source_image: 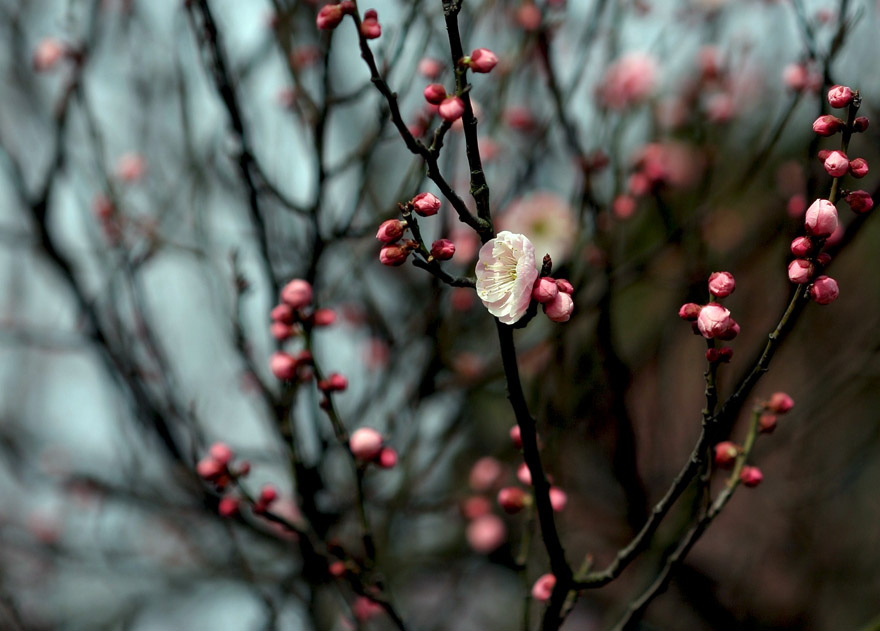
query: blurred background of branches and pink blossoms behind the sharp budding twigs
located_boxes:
[0,0,880,631]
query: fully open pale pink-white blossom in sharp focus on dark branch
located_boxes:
[476,230,538,324]
